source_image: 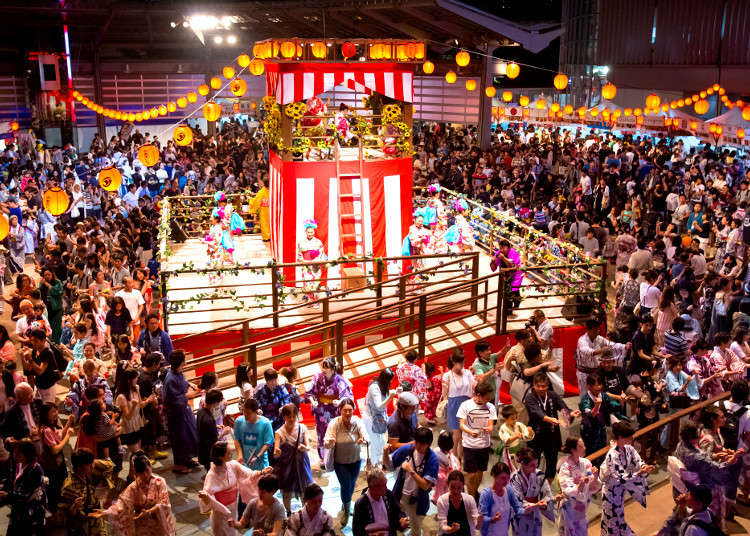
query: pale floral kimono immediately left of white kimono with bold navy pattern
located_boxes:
[558,457,602,536]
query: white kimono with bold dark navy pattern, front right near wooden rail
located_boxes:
[599,445,649,536]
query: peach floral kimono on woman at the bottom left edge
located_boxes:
[105,475,176,536]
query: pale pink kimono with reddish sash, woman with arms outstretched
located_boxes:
[198,460,260,536]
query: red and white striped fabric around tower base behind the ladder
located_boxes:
[269,152,412,280]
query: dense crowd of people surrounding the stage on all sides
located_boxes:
[0,115,750,536]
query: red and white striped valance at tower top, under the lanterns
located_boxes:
[266,63,414,104]
